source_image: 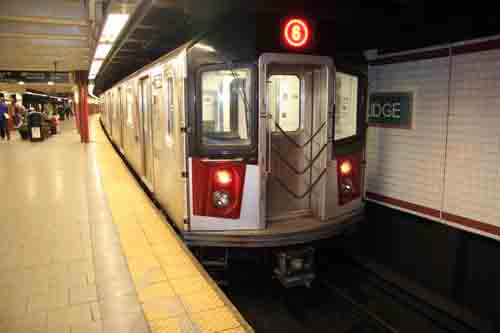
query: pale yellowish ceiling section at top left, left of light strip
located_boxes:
[0,0,90,71]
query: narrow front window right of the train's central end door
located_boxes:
[335,72,358,141]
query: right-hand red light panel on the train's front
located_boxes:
[337,153,361,205]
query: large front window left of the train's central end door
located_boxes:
[201,69,251,146]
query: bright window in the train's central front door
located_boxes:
[268,75,301,132]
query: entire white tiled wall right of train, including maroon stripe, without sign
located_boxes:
[366,37,500,239]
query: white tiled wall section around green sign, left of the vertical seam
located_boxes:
[366,58,449,209]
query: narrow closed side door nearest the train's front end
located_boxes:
[139,77,153,190]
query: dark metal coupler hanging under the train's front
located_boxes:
[274,246,316,288]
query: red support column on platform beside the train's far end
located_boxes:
[74,71,89,143]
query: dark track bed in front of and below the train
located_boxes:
[225,245,492,333]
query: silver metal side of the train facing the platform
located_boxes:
[102,50,187,228]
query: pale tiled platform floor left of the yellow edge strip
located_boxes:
[0,120,148,333]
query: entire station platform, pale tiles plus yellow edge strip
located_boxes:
[0,116,253,333]
